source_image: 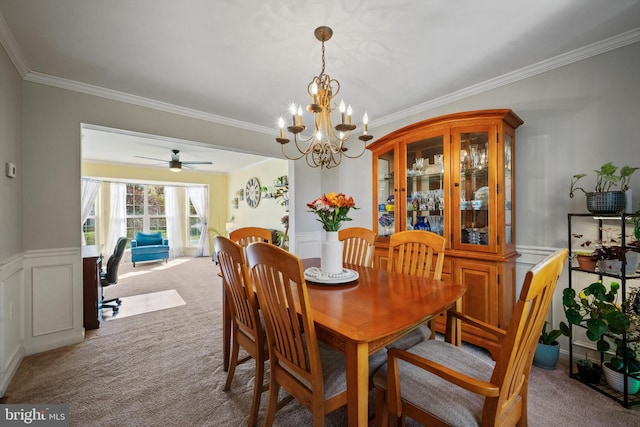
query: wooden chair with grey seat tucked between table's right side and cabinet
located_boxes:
[387,230,445,349]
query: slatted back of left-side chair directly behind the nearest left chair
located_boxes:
[213,236,262,342]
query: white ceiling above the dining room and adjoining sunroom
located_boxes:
[0,0,640,172]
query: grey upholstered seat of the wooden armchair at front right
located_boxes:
[373,340,494,427]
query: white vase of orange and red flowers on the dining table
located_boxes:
[307,193,357,276]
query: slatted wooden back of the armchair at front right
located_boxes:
[483,249,568,425]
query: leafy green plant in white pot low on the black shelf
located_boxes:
[560,281,640,394]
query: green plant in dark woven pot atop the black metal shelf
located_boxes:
[569,162,638,214]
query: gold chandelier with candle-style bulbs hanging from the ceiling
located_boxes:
[276,27,373,169]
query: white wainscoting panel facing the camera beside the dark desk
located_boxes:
[24,248,84,354]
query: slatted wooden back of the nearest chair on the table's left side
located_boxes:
[247,242,324,403]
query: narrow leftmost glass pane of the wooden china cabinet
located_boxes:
[378,150,396,236]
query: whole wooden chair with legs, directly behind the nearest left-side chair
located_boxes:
[213,236,269,426]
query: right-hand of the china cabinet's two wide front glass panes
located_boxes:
[458,132,493,246]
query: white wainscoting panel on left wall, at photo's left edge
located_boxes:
[0,254,24,396]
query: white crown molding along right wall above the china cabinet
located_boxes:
[376,27,640,128]
